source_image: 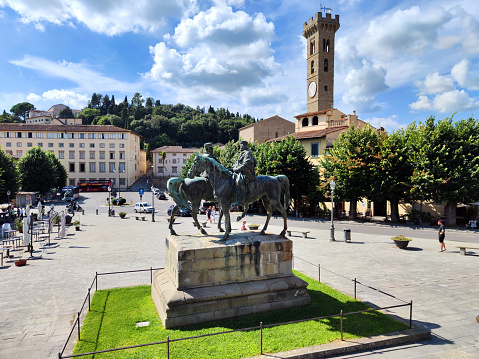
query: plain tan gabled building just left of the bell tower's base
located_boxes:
[238,115,295,143]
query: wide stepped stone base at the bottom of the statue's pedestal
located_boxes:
[151,269,311,329]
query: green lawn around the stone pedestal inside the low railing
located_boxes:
[74,272,407,359]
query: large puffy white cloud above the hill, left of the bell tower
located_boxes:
[144,6,279,103]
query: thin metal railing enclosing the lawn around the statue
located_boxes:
[58,266,412,359]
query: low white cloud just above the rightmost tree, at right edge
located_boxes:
[409,90,479,113]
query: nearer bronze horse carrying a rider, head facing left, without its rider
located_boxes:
[188,155,290,241]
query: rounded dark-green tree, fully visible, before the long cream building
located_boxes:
[17,146,57,195]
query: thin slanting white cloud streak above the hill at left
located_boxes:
[10,55,134,92]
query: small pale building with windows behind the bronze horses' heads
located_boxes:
[151,146,201,178]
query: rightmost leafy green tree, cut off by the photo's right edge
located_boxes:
[412,117,479,225]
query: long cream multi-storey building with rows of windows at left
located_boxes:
[0,123,146,189]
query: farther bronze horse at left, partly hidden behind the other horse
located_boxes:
[166,177,224,235]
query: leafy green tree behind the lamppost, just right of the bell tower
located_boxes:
[321,126,380,219]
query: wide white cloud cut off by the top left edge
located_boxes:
[0,0,197,36]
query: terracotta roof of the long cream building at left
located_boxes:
[0,123,139,136]
